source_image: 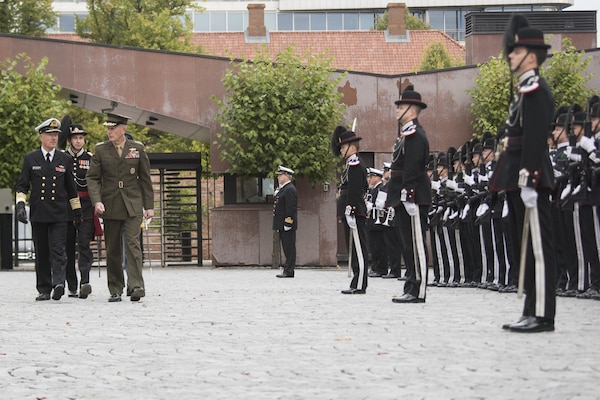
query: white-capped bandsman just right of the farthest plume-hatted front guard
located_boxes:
[367,168,388,278]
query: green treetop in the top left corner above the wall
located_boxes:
[0,0,58,36]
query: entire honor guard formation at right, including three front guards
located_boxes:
[332,15,600,332]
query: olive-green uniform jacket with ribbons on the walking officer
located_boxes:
[87,140,154,220]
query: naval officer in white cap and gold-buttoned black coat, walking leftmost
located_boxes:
[16,118,81,301]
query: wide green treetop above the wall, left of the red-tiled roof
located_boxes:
[75,0,202,52]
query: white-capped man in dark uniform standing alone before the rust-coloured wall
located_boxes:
[273,165,298,278]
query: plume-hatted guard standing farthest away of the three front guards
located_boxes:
[331,126,368,294]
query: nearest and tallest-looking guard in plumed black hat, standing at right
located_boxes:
[490,15,556,332]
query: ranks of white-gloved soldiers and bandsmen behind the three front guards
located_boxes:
[365,97,600,300]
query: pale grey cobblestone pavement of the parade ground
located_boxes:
[0,267,600,400]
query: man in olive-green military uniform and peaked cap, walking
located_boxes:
[87,114,154,303]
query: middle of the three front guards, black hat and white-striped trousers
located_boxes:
[386,86,431,303]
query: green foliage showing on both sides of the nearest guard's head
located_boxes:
[467,38,595,139]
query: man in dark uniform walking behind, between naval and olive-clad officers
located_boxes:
[66,125,94,299]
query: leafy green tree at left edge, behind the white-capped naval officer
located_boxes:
[0,53,68,188]
